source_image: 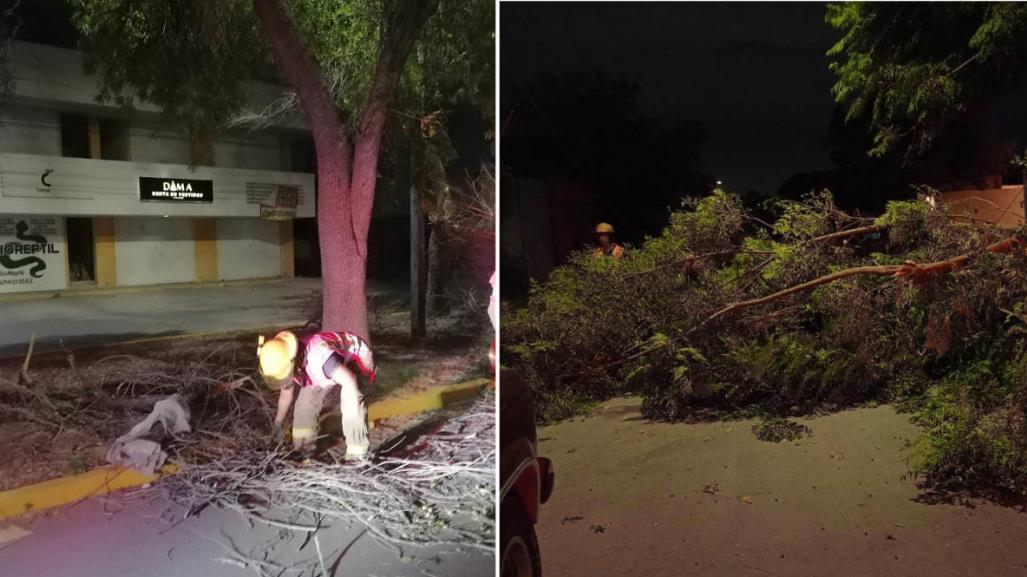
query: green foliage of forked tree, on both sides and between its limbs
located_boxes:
[71,0,494,150]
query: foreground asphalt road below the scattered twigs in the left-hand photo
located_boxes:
[0,491,495,577]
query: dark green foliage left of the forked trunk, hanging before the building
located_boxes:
[71,0,263,133]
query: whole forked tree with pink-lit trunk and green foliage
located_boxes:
[72,0,492,337]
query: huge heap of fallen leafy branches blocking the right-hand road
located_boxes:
[503,191,1027,493]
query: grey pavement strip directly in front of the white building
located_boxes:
[0,278,320,357]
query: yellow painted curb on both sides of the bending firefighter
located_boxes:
[0,378,491,522]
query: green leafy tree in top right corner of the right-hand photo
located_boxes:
[827,2,1027,182]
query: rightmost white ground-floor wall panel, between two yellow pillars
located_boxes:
[218,219,281,280]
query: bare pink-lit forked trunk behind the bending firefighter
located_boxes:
[254,0,435,342]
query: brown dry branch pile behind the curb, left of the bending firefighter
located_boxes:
[0,343,273,461]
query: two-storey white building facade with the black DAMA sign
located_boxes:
[0,43,316,294]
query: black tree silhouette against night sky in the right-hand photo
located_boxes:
[501,70,710,242]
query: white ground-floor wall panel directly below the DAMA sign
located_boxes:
[114,217,196,286]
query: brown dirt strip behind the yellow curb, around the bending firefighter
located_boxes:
[0,312,488,491]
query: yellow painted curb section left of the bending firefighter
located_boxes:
[0,465,178,521]
